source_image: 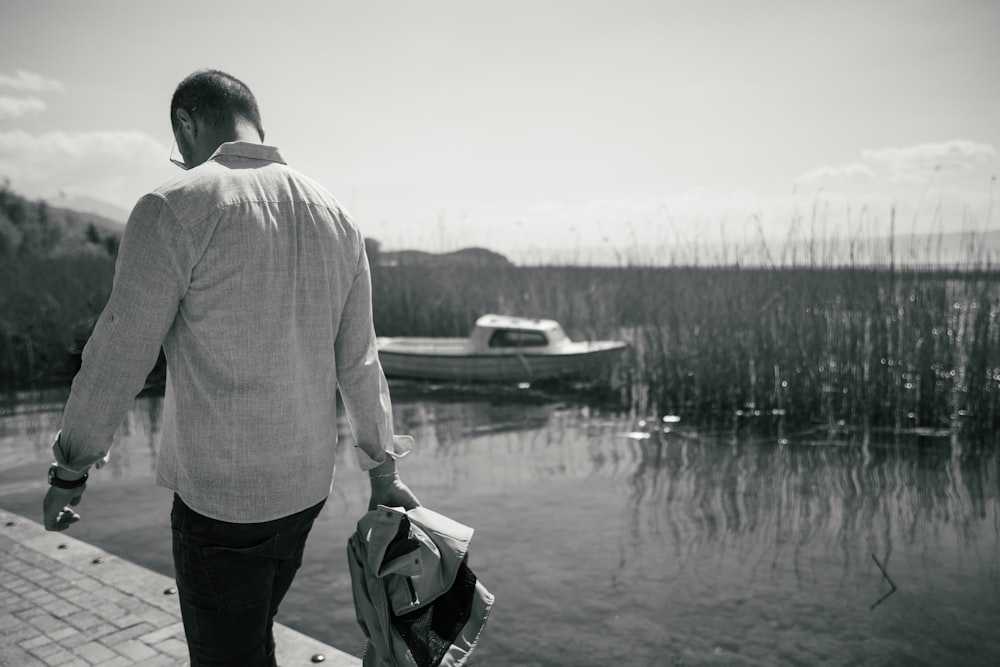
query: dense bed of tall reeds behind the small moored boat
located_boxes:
[373,266,1000,437]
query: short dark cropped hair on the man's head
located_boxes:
[170,69,264,141]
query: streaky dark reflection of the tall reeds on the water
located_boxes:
[604,431,1000,585]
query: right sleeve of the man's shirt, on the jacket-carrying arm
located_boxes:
[335,235,413,470]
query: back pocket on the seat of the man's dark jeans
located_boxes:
[198,535,278,611]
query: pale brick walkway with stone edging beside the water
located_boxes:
[0,508,361,667]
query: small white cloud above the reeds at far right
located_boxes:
[861,140,997,180]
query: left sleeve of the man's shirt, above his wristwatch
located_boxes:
[53,194,192,472]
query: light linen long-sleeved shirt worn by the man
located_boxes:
[53,142,406,523]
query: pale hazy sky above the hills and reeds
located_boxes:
[0,0,1000,263]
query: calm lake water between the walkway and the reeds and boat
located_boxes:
[0,385,1000,666]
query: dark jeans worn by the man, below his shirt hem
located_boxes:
[170,494,326,667]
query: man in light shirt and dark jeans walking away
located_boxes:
[43,70,419,667]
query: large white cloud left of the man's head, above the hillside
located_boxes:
[0,130,175,208]
